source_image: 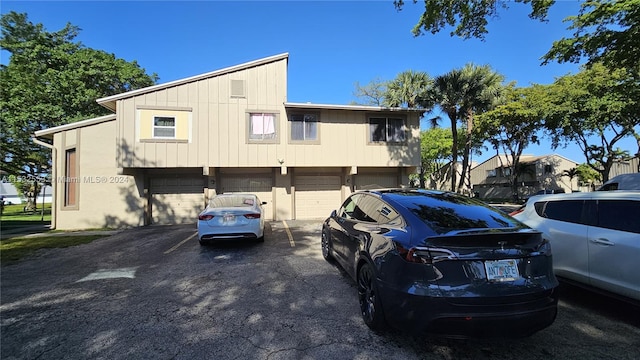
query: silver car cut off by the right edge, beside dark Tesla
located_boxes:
[512,190,640,300]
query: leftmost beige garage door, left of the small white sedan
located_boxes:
[150,176,204,224]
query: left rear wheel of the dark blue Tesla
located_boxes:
[357,264,386,331]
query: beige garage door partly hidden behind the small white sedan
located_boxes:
[220,174,273,220]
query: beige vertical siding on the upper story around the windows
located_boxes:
[116,59,420,172]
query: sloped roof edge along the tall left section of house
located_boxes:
[96,53,289,111]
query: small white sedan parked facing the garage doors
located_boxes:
[197,193,266,245]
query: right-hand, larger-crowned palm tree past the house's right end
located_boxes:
[426,64,504,191]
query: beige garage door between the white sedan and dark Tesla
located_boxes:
[295,176,342,219]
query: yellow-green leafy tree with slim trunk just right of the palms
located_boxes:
[476,84,545,200]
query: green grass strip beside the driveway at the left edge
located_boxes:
[0,235,109,266]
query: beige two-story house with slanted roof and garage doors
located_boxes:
[35,53,423,229]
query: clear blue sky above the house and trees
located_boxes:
[0,0,637,163]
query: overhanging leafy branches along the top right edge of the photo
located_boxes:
[394,0,640,71]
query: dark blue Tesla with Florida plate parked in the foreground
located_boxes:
[321,189,558,337]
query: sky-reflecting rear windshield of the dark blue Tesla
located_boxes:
[394,192,524,235]
